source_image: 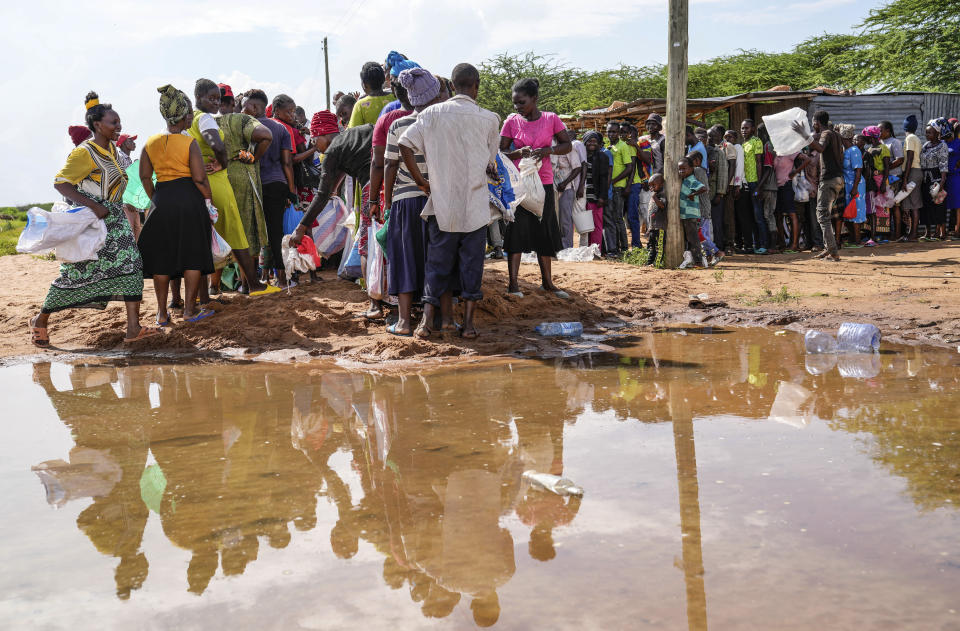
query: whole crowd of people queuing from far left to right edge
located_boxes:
[29,51,960,346]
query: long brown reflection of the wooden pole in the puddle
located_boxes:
[670,383,707,631]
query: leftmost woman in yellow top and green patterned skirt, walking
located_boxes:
[29,92,158,347]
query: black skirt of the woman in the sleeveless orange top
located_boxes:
[137,177,213,278]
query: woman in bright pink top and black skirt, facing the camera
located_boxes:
[500,79,573,298]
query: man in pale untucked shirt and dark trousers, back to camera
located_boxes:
[400,64,500,339]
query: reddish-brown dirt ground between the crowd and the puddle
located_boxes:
[0,242,960,363]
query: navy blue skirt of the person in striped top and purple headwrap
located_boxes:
[387,197,427,301]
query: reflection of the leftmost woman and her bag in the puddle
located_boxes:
[33,363,150,600]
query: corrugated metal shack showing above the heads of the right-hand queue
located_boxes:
[571,90,960,133]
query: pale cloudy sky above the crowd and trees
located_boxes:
[0,0,876,205]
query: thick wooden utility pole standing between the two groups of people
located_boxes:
[663,0,689,268]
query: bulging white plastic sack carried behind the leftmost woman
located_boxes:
[17,202,107,263]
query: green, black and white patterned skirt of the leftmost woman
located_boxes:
[43,196,143,313]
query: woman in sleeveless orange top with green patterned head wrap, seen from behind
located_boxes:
[138,85,213,326]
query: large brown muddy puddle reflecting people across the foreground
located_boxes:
[0,328,960,630]
